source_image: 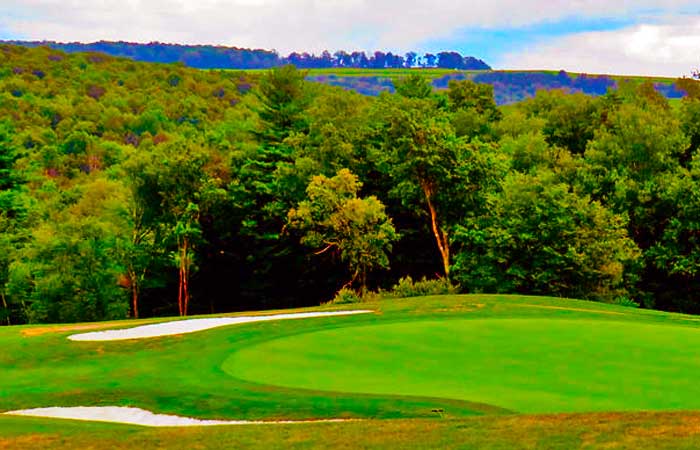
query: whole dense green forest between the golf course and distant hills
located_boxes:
[0,45,700,324]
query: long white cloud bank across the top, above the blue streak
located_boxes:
[0,0,697,52]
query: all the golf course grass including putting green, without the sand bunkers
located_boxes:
[0,295,700,449]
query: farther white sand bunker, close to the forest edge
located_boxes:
[68,310,373,341]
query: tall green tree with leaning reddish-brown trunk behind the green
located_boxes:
[374,96,500,276]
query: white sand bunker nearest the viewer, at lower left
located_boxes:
[3,406,357,427]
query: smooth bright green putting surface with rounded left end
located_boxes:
[224,319,700,413]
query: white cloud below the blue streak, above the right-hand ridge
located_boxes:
[497,16,700,77]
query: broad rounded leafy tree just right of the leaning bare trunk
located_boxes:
[454,172,639,301]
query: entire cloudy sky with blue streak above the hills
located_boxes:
[0,0,700,77]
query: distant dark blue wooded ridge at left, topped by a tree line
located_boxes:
[0,41,491,70]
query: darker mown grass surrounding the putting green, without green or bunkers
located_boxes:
[0,296,700,448]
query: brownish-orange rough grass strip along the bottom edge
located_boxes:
[0,412,700,450]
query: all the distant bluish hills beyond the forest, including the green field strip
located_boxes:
[0,41,684,105]
